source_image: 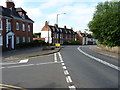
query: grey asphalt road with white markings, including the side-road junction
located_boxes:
[1,46,119,90]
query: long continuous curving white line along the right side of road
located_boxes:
[77,47,120,71]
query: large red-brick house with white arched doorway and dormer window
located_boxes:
[0,0,34,50]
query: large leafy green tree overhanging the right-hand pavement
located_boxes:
[88,1,120,47]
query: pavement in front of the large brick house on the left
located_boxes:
[2,47,61,61]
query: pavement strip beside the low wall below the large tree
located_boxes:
[89,45,120,59]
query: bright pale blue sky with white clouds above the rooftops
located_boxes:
[0,0,114,33]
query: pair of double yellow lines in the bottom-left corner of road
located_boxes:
[0,84,27,90]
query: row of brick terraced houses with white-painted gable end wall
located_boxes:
[41,21,75,44]
